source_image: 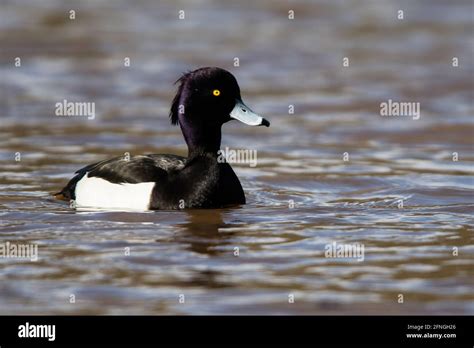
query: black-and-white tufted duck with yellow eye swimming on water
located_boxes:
[55,67,270,210]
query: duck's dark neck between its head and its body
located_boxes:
[181,120,222,158]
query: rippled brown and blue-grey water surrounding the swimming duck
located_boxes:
[0,0,474,314]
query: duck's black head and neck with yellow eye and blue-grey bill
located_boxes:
[170,67,270,155]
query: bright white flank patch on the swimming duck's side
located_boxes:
[76,173,155,210]
